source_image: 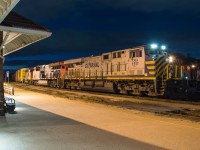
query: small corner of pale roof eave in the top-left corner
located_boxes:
[0,0,20,23]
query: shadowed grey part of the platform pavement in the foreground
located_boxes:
[0,102,162,150]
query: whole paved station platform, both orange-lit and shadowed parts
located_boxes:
[0,88,200,150]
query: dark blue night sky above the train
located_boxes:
[4,0,200,70]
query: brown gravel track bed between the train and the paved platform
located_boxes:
[10,83,200,122]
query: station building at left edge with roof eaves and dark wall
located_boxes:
[0,0,51,116]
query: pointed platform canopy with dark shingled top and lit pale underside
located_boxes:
[0,11,51,56]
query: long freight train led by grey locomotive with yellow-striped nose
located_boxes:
[15,45,200,98]
